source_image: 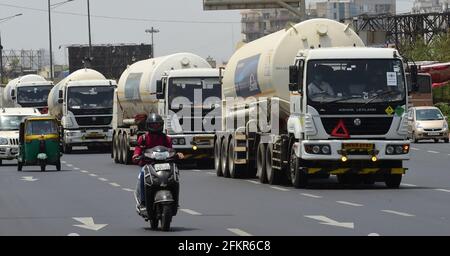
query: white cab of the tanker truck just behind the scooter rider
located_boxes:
[157,68,222,160]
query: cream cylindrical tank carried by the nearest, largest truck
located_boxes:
[222,19,364,116]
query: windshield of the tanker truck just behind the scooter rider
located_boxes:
[168,78,222,109]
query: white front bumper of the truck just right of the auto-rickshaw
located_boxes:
[64,129,113,146]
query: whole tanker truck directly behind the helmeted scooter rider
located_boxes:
[111,53,222,165]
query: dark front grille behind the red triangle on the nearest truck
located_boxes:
[322,117,393,135]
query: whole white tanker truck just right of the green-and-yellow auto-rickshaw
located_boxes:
[48,69,116,153]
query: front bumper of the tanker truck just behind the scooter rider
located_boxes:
[170,134,214,160]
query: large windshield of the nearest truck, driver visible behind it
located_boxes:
[307,59,406,104]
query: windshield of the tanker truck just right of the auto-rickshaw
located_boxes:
[67,86,114,112]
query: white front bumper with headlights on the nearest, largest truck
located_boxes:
[294,140,410,161]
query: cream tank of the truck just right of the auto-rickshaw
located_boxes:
[48,68,106,118]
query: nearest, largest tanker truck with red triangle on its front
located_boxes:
[214,19,409,188]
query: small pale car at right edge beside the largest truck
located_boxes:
[408,107,449,143]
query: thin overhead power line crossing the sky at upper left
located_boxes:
[0,4,240,24]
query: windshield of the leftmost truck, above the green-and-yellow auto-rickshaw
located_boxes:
[17,85,52,106]
